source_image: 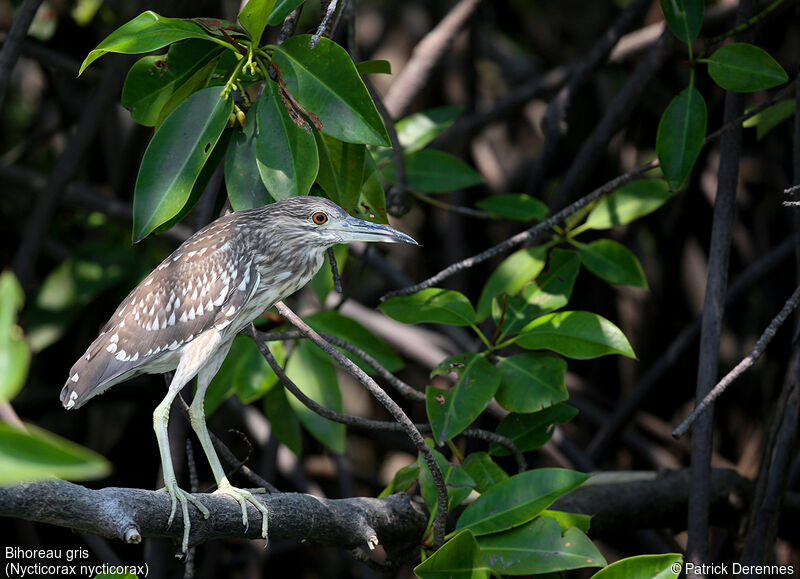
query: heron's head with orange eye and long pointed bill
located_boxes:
[265,196,419,247]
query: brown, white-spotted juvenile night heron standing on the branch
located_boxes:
[61,197,416,551]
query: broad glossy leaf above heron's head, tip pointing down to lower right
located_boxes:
[272,35,389,147]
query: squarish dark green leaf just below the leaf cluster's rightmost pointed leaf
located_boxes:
[495,352,569,412]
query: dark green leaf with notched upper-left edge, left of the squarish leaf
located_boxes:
[425,352,500,444]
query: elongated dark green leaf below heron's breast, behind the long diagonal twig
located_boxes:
[305,310,403,374]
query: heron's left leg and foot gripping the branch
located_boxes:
[153,365,210,553]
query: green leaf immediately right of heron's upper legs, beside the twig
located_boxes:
[205,336,283,416]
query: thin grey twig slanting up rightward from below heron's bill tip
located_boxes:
[381,160,658,301]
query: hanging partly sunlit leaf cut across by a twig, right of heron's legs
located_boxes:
[286,342,345,453]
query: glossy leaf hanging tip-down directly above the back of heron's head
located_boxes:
[256,82,319,201]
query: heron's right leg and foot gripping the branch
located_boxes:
[189,343,268,539]
